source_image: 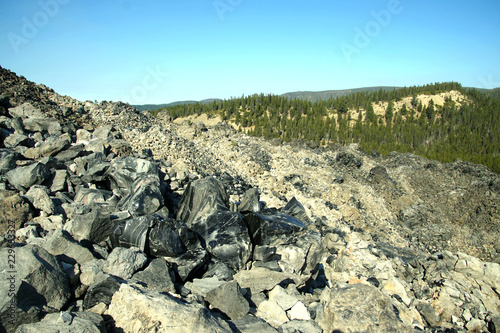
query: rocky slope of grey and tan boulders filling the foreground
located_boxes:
[0,68,500,332]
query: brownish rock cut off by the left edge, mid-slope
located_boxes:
[0,190,33,236]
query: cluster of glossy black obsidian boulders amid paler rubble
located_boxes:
[110,177,309,281]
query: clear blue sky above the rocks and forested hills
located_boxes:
[0,0,500,104]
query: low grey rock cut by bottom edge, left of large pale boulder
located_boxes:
[16,312,106,333]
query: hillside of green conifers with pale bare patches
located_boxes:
[151,82,500,173]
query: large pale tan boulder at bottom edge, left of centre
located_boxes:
[107,284,232,333]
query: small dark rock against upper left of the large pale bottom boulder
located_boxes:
[83,274,125,310]
